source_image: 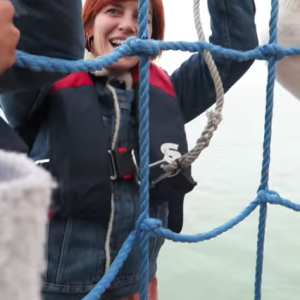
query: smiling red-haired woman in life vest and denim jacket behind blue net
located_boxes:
[0,0,258,300]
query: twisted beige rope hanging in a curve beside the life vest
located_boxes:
[162,0,224,173]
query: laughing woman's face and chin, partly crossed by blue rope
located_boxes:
[90,0,152,71]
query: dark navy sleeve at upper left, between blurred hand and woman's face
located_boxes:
[0,0,84,125]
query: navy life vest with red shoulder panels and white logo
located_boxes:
[25,64,195,224]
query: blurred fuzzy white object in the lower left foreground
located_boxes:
[0,150,55,300]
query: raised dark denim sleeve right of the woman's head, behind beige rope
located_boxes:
[171,0,258,123]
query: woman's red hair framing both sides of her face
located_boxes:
[82,0,165,57]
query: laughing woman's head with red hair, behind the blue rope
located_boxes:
[82,0,165,70]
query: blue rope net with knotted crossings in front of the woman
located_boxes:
[12,0,300,300]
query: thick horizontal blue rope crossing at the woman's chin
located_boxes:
[15,37,300,74]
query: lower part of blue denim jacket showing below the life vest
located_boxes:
[43,199,167,300]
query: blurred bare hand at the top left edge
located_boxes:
[0,0,20,75]
